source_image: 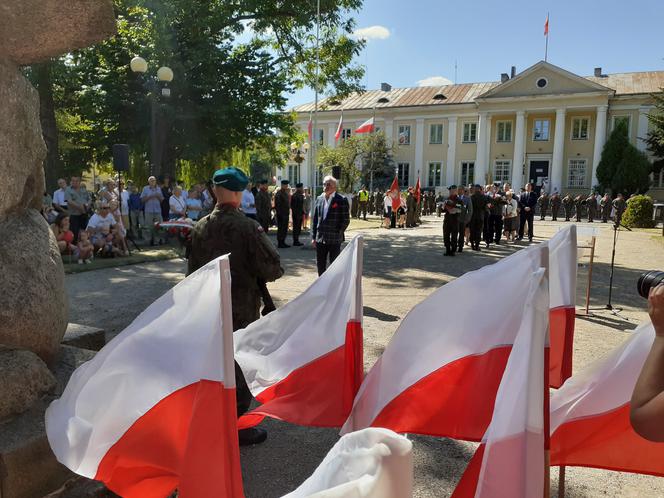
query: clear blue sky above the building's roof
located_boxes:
[288,0,664,108]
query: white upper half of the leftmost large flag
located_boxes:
[46,256,234,478]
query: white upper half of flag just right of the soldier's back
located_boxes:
[234,236,362,396]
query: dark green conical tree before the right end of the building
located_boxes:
[597,123,652,195]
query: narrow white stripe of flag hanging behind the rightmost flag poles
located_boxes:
[547,225,577,309]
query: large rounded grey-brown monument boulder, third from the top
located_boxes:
[0,209,67,364]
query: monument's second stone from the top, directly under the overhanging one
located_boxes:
[0,57,46,220]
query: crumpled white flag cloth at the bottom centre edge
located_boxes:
[283,428,413,498]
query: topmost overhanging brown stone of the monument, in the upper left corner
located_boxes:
[0,0,115,65]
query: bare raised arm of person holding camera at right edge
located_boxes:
[630,282,664,442]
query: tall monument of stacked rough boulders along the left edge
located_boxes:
[0,0,115,498]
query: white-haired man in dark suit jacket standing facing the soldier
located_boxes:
[311,176,350,276]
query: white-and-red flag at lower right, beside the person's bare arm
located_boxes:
[551,322,664,476]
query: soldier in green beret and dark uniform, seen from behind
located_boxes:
[189,168,284,445]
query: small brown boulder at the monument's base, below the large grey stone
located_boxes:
[0,347,56,420]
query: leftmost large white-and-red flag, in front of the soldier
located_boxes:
[46,256,244,498]
